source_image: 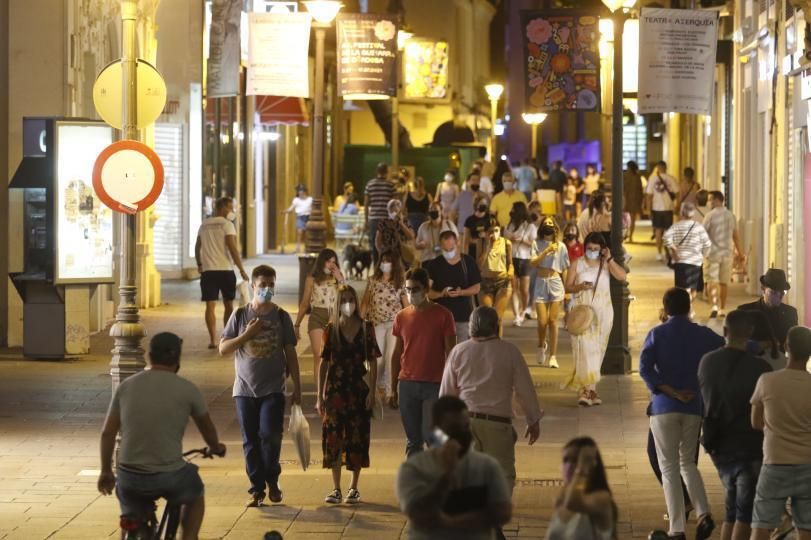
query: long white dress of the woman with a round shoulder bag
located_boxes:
[566,257,614,390]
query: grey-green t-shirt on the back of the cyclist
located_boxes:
[108,369,208,473]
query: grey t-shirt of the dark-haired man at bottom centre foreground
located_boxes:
[397,448,511,540]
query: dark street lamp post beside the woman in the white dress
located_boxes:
[602,0,636,375]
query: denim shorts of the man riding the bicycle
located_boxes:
[115,463,204,518]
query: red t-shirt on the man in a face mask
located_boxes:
[393,303,456,383]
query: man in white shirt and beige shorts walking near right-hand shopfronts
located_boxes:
[703,191,744,319]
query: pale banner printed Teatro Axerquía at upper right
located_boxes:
[628,8,718,115]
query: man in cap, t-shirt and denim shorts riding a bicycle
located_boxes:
[98,332,225,540]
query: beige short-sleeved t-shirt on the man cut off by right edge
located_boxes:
[752,369,811,465]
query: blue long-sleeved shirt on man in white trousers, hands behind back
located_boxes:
[639,317,725,416]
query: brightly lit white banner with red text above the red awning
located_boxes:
[246,13,311,97]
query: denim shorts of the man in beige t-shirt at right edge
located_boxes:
[752,465,811,530]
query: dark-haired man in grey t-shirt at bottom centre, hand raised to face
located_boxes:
[396,396,512,540]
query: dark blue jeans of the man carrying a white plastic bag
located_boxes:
[234,393,285,494]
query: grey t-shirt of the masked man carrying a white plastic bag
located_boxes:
[222,304,296,397]
